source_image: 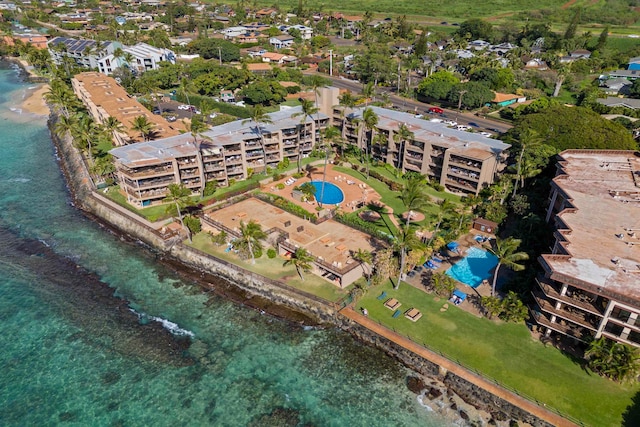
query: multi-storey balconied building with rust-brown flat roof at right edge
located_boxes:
[532,150,640,347]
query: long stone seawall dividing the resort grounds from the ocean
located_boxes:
[49,115,568,427]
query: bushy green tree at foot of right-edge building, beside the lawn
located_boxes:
[584,336,640,381]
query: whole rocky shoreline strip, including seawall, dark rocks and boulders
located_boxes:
[41,77,550,427]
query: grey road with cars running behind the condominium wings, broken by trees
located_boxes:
[321,74,512,133]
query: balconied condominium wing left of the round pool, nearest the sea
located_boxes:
[110,107,329,206]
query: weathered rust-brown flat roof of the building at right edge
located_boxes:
[543,150,640,300]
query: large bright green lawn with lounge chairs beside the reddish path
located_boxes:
[356,283,640,426]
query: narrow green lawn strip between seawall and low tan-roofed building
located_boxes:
[187,233,356,301]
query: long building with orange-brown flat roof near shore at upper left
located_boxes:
[71,71,184,145]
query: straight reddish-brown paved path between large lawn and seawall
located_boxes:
[340,307,577,427]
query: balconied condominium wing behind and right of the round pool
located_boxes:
[333,107,510,195]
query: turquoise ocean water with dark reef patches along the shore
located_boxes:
[0,63,448,426]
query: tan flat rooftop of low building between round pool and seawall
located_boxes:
[209,198,378,267]
